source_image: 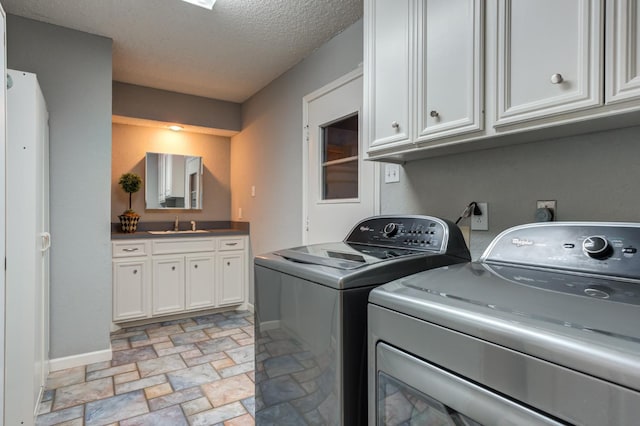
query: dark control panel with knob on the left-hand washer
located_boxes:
[345,216,460,251]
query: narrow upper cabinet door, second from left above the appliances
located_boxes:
[415,0,484,140]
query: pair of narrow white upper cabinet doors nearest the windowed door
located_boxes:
[364,0,484,153]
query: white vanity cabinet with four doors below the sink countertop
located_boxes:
[112,236,248,322]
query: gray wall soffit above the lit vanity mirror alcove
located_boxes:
[113,81,241,130]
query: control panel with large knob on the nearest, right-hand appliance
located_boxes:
[480,222,640,279]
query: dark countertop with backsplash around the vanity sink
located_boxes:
[111,221,249,240]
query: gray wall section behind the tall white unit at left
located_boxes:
[7,15,111,358]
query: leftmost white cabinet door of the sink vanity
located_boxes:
[113,259,149,321]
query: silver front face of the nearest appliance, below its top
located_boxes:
[368,303,640,426]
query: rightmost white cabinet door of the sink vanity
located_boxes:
[218,251,246,306]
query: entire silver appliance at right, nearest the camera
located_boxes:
[368,222,640,426]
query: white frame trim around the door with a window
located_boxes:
[301,65,380,245]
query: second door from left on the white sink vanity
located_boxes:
[152,256,184,315]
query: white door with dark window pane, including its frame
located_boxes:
[303,69,379,244]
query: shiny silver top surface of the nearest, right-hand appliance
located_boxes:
[369,263,640,390]
